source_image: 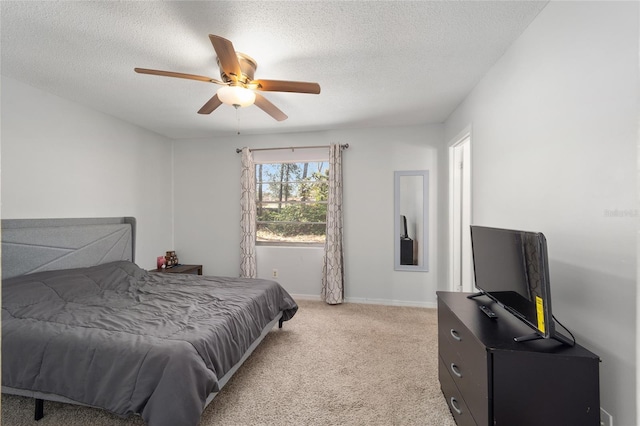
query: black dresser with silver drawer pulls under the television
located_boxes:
[438,292,600,426]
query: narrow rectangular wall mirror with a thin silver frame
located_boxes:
[393,170,429,271]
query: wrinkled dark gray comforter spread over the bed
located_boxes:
[2,261,297,426]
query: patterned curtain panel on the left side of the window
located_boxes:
[240,147,258,278]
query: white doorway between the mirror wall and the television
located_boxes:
[449,131,474,292]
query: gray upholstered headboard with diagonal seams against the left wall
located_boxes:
[2,217,136,279]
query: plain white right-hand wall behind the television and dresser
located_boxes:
[445,2,639,426]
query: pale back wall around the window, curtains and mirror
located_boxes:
[174,125,443,306]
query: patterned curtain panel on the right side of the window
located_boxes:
[321,144,344,305]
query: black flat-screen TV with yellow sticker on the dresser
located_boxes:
[470,225,575,345]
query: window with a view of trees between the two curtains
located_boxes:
[256,161,329,244]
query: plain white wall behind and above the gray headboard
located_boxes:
[0,77,172,268]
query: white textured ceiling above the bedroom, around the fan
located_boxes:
[0,0,547,139]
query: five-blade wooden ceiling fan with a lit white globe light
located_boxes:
[134,34,320,121]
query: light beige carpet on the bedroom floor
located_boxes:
[2,300,455,426]
